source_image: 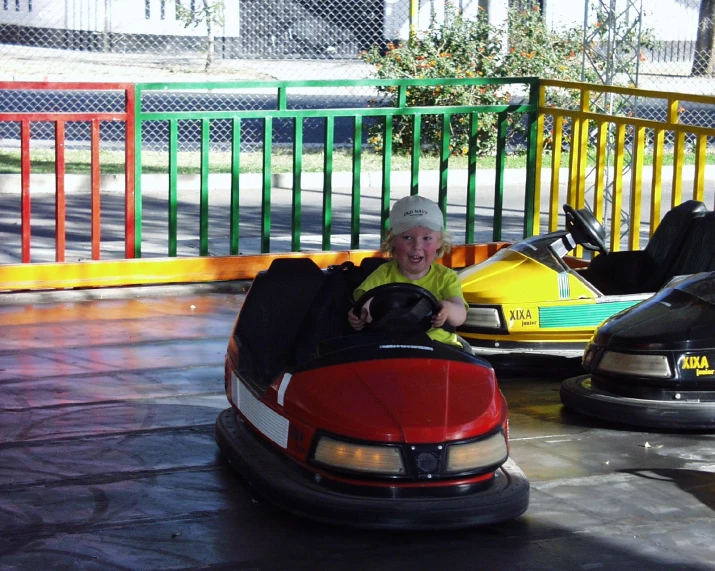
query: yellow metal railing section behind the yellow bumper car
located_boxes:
[534,80,715,251]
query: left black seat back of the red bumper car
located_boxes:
[234,258,325,387]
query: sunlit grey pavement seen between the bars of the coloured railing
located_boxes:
[0,165,715,264]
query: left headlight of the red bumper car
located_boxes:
[313,436,406,476]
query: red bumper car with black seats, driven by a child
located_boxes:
[216,259,529,529]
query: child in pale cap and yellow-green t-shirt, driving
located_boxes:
[348,195,468,347]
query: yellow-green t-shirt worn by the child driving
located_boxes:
[353,260,469,347]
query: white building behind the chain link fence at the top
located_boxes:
[0,0,698,57]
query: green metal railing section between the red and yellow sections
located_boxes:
[134,77,539,258]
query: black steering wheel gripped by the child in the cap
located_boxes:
[353,283,440,333]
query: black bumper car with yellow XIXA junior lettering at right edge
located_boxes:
[561,272,715,430]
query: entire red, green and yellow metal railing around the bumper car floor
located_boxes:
[0,78,715,290]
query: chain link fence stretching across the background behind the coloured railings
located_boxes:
[0,0,715,155]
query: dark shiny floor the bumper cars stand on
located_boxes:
[0,290,715,571]
